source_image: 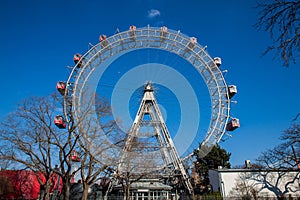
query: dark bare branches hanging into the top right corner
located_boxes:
[255,0,300,67]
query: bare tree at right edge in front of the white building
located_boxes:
[253,123,300,198]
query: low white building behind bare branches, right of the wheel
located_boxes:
[209,169,300,199]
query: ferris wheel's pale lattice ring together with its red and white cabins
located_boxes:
[56,26,239,191]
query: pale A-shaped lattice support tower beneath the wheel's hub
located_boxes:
[118,83,193,193]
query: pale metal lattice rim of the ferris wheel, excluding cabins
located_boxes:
[64,26,230,159]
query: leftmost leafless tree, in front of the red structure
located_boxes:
[0,96,77,199]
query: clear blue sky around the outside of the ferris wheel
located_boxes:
[0,0,300,165]
